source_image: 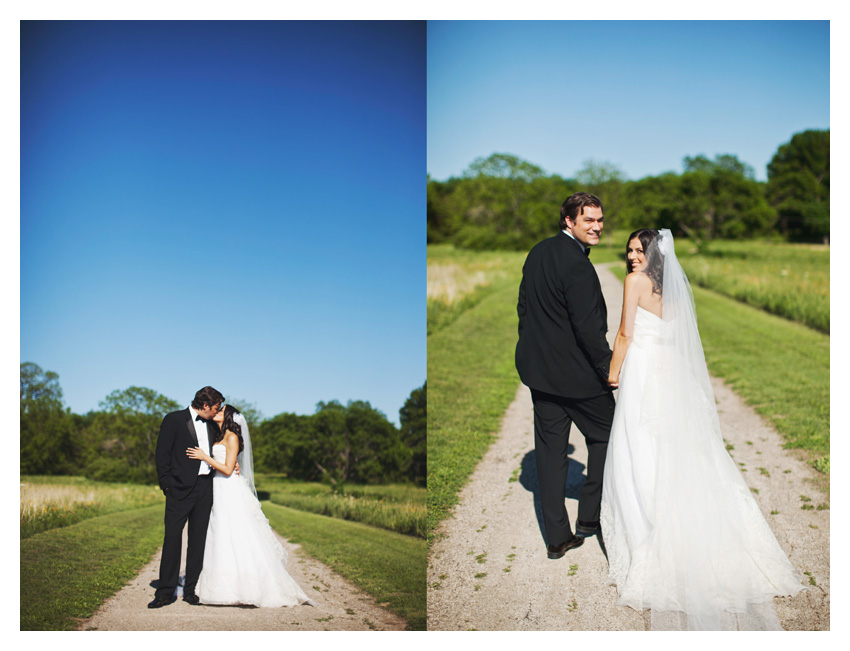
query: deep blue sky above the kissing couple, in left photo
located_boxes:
[20,21,426,423]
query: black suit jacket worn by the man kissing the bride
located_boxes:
[156,407,219,499]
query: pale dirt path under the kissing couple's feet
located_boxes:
[80,531,406,631]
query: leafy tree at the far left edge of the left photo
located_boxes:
[20,362,78,475]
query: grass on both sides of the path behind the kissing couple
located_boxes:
[20,477,426,630]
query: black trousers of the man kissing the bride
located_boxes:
[156,473,213,597]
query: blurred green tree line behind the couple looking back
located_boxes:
[428,130,829,250]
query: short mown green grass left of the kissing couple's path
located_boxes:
[20,506,164,631]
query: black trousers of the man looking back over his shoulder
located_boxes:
[531,389,614,545]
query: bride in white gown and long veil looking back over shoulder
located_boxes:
[600,229,804,630]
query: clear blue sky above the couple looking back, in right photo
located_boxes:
[428,21,830,180]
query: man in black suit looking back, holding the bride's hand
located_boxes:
[516,192,614,558]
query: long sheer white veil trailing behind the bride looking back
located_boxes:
[621,229,802,630]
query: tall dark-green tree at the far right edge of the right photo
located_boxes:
[767,129,829,241]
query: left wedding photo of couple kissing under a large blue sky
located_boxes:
[20,20,427,631]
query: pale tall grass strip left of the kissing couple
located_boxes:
[20,476,165,539]
